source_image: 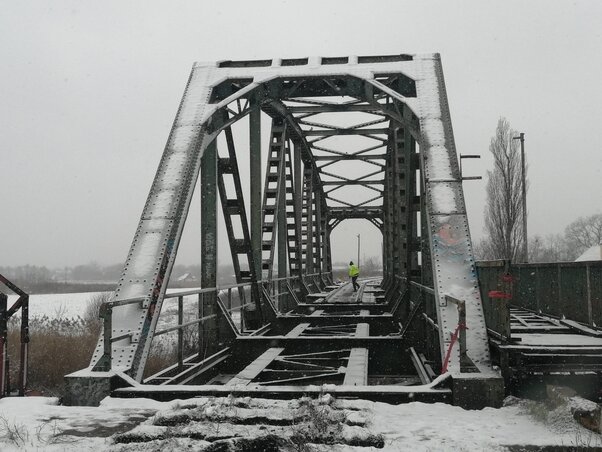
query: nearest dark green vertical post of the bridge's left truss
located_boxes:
[199,139,219,357]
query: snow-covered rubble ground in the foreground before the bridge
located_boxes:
[0,395,602,452]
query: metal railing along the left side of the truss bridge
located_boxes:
[94,273,329,371]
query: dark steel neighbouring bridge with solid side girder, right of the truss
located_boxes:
[478,261,602,400]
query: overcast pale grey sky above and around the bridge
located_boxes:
[0,0,602,266]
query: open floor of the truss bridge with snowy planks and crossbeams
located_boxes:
[114,280,451,402]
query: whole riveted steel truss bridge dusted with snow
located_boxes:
[66,54,576,407]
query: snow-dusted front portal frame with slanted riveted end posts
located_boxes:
[72,54,490,381]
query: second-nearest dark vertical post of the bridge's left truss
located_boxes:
[249,97,262,282]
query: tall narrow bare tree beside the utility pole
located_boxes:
[483,118,526,261]
